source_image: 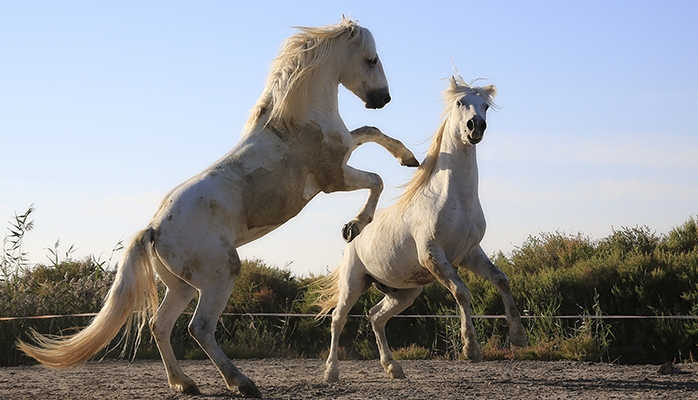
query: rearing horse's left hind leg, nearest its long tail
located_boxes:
[150,260,199,394]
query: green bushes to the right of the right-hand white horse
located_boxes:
[495,222,698,363]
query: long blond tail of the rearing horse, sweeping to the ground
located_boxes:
[17,229,158,368]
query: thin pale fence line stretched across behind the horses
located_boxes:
[0,312,698,322]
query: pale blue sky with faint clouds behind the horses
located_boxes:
[0,0,698,275]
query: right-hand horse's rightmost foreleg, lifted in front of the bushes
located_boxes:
[462,246,527,347]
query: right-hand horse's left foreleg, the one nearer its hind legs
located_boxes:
[422,245,482,361]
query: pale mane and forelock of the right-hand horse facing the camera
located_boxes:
[396,74,498,210]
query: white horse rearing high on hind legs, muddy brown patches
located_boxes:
[18,18,418,396]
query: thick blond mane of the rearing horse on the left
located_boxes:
[243,16,376,135]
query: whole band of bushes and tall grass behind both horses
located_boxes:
[0,208,698,365]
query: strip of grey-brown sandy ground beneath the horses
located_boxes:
[0,359,698,400]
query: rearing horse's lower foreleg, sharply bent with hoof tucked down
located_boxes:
[334,165,383,243]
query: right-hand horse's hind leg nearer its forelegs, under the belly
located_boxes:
[369,286,422,378]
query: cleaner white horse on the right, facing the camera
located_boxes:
[317,77,526,382]
